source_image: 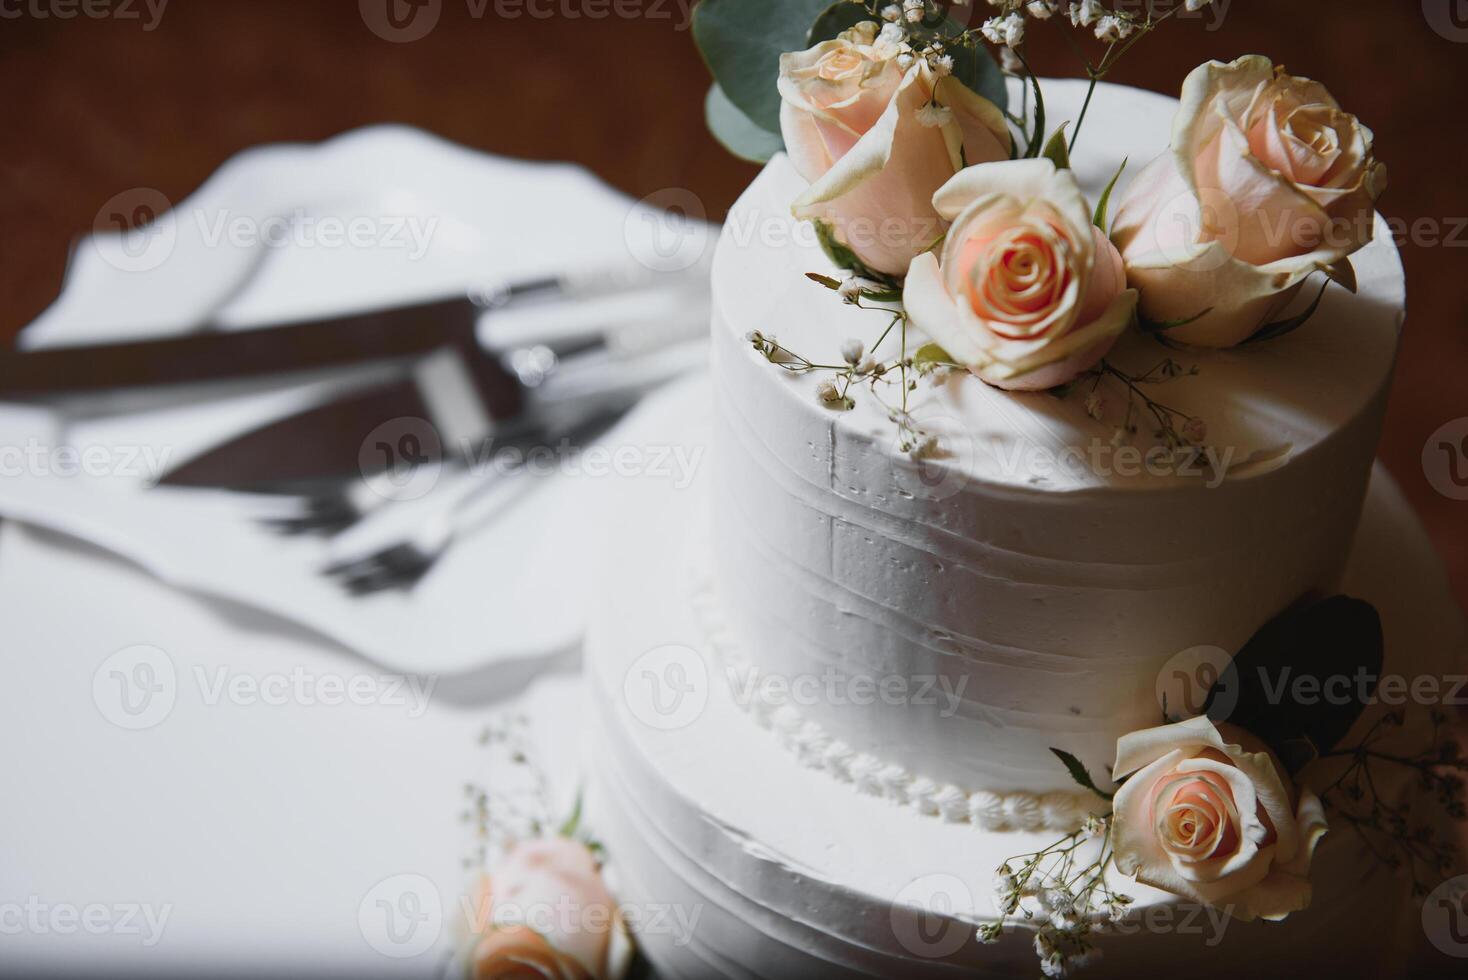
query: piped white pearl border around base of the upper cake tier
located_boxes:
[690,575,1100,833]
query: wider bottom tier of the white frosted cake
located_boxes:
[586,381,1468,979]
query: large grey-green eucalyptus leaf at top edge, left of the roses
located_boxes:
[693,0,831,134]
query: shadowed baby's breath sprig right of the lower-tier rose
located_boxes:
[1320,710,1468,898]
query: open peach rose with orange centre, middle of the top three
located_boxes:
[903,160,1136,390]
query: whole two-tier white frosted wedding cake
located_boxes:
[587,72,1464,977]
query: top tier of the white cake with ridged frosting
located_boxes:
[712,81,1403,795]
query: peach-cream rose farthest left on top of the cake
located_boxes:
[780,22,1010,276]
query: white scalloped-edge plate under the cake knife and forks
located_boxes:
[0,126,713,672]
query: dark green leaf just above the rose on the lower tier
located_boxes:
[1204,596,1384,773]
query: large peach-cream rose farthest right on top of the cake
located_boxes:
[1111,54,1386,348]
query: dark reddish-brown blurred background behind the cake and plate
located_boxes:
[0,0,1468,606]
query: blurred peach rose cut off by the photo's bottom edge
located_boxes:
[471,838,631,980]
